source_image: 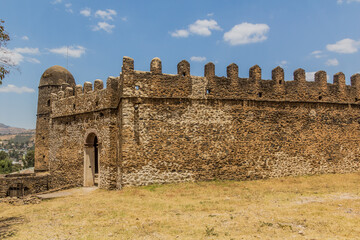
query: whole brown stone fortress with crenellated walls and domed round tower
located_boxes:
[0,57,360,197]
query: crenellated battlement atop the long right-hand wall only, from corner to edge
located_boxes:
[121,57,360,103]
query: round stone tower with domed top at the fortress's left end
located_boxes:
[35,65,76,172]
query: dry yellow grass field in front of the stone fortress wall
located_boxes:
[0,174,360,239]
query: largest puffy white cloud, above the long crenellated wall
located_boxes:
[224,22,270,46]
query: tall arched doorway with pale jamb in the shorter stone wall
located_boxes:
[84,133,99,187]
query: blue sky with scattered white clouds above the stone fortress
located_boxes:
[0,0,360,128]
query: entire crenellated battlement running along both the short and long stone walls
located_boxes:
[51,57,360,117]
